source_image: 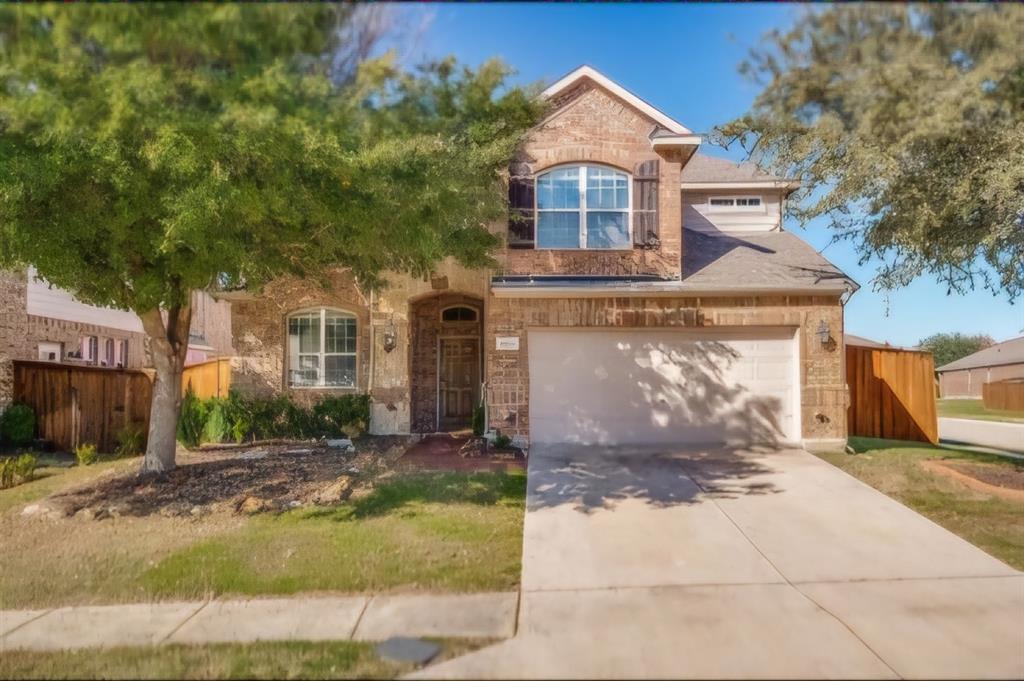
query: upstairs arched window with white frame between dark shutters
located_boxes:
[537,166,633,249]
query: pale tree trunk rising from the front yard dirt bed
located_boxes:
[139,305,191,473]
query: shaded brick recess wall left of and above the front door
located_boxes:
[409,293,483,433]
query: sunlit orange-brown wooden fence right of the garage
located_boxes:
[846,345,939,444]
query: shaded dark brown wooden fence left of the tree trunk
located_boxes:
[14,360,153,452]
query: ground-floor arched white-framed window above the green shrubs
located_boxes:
[288,307,356,388]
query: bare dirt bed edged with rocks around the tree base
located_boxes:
[45,436,410,519]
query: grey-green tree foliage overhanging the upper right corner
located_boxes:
[716,3,1024,301]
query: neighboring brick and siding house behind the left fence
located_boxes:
[0,269,231,408]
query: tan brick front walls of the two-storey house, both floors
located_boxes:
[233,71,847,440]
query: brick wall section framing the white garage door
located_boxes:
[484,296,847,440]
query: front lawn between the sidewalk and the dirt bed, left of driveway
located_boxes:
[0,457,526,609]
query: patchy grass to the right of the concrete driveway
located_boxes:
[818,437,1024,569]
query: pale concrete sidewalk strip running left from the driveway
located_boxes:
[0,592,518,651]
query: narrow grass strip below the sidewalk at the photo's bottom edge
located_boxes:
[0,641,475,679]
